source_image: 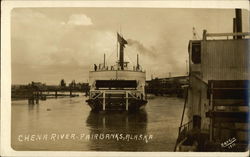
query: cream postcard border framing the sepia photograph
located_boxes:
[0,0,249,157]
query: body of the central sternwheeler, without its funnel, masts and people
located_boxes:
[86,70,147,111]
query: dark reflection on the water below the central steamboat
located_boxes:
[86,111,150,151]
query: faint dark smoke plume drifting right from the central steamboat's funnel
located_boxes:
[127,39,156,56]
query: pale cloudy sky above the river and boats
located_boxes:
[11,8,249,85]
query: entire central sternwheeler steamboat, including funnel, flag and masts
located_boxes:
[87,33,147,111]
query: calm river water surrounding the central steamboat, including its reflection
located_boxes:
[11,95,184,151]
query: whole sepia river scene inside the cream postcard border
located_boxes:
[1,0,250,156]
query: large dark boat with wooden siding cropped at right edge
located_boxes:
[175,9,250,152]
